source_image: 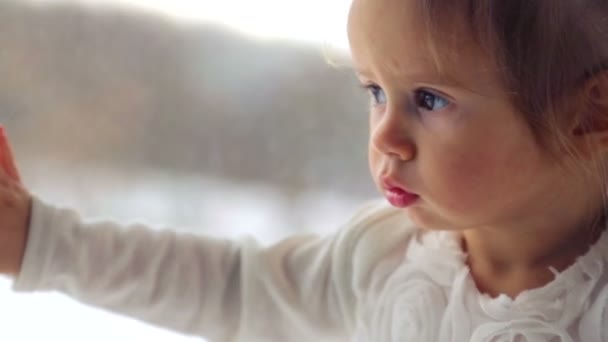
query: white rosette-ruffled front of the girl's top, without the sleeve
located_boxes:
[354,220,608,342]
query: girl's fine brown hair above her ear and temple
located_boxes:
[417,0,608,150]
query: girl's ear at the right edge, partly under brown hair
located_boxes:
[570,71,608,158]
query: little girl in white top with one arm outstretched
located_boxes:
[0,0,608,342]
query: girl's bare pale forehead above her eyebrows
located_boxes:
[348,0,497,91]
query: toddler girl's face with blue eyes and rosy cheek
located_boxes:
[349,0,572,229]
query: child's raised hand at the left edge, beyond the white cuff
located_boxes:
[0,126,32,276]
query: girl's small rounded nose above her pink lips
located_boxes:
[370,108,416,161]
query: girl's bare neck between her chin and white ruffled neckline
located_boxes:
[463,207,604,297]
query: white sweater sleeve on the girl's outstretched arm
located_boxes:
[13,197,414,341]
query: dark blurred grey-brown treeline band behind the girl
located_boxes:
[0,0,373,196]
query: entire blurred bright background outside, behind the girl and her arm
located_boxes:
[0,0,376,342]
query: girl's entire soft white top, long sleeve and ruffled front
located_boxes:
[14,198,608,342]
